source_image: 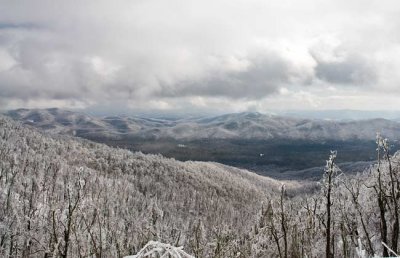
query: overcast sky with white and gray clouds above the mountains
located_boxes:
[0,0,400,113]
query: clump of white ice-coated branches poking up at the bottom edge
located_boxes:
[124,241,195,258]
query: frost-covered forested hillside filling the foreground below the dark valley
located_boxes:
[0,117,400,258]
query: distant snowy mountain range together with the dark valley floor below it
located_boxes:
[6,109,400,180]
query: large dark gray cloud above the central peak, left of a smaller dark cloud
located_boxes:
[157,51,312,99]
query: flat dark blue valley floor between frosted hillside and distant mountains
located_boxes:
[92,137,382,180]
